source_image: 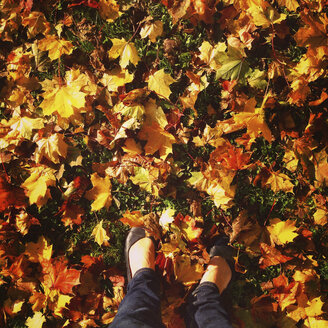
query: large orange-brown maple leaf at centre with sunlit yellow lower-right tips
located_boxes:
[138,124,175,160]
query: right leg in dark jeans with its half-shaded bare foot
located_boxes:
[186,256,232,328]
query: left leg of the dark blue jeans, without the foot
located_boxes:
[109,268,165,328]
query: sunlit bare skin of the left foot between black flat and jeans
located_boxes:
[129,237,155,277]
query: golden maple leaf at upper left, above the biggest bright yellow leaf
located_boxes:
[38,34,73,60]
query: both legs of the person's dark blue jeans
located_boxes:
[109,268,232,328]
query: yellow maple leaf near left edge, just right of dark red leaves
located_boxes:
[22,166,56,207]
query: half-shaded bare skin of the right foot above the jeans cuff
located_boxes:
[200,256,232,294]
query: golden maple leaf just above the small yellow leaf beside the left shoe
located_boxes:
[85,173,112,211]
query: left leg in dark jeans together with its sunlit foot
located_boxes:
[109,231,164,328]
